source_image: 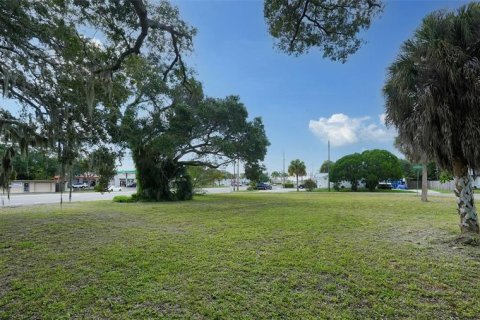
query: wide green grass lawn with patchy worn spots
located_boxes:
[0,192,480,319]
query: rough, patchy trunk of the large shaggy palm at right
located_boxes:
[453,160,480,239]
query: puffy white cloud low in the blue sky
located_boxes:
[308,113,395,147]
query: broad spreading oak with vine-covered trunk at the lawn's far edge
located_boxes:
[122,90,269,200]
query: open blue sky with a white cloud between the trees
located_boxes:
[175,1,464,172]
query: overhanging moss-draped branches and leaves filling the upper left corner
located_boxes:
[0,0,195,202]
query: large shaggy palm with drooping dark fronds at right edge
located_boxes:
[384,3,480,243]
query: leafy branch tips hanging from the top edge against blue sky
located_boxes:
[264,0,383,62]
